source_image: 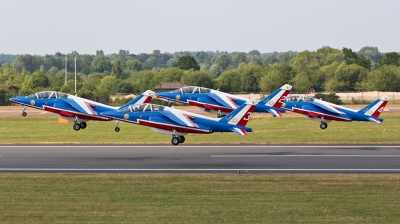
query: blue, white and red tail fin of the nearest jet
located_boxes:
[219,99,259,126]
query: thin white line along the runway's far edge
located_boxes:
[0,145,400,148]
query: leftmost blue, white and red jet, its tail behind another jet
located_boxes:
[9,90,154,131]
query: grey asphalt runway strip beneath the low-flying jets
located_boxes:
[0,144,400,173]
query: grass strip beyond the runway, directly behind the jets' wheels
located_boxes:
[0,112,400,144]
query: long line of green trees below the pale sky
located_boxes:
[0,47,400,104]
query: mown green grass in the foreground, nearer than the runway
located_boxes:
[0,174,400,223]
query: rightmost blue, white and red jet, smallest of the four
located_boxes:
[282,96,389,129]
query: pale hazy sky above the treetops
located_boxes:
[0,0,400,55]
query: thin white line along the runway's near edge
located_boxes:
[0,168,400,172]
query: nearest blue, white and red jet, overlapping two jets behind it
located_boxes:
[101,99,258,145]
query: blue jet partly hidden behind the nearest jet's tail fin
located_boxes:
[156,84,292,117]
